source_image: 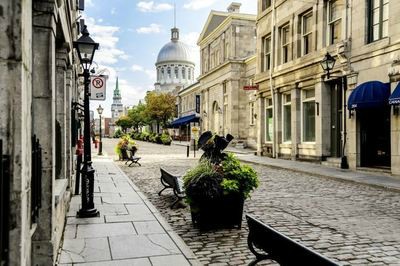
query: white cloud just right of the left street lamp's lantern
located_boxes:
[85,17,128,65]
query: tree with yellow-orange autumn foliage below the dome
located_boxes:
[145,91,176,130]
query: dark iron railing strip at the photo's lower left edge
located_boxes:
[0,140,11,266]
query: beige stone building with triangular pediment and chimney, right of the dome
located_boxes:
[198,3,257,147]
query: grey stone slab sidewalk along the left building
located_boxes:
[58,157,200,266]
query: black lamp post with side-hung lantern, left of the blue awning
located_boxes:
[320,52,349,169]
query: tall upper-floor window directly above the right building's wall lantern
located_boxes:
[328,0,343,45]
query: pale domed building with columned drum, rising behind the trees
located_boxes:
[154,28,195,94]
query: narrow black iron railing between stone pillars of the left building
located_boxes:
[31,135,42,223]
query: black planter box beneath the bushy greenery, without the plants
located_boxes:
[190,194,244,229]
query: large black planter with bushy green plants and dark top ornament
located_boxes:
[183,132,259,229]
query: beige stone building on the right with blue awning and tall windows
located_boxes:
[255,0,400,174]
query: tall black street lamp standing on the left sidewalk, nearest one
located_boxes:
[73,25,100,218]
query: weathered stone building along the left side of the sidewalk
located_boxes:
[0,0,85,265]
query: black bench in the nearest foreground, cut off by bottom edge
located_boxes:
[246,215,340,266]
